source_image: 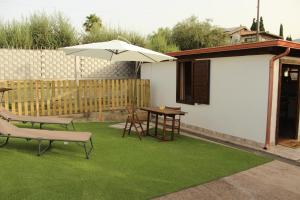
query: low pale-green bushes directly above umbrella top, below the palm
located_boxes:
[82,25,146,47]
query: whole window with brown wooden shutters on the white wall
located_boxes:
[176,60,210,104]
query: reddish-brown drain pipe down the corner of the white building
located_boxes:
[264,47,291,149]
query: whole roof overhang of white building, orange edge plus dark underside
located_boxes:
[167,40,300,59]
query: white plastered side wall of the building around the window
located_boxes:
[141,55,276,143]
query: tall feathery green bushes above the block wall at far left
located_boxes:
[0,13,78,49]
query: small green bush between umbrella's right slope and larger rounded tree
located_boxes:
[146,28,179,53]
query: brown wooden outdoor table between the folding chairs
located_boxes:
[140,107,186,141]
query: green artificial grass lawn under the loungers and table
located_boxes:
[0,123,270,200]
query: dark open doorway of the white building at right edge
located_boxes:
[277,64,299,140]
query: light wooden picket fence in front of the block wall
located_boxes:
[0,79,150,119]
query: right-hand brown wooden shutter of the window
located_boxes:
[193,60,210,104]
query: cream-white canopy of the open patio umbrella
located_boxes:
[61,40,176,63]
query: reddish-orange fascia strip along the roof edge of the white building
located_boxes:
[167,40,300,57]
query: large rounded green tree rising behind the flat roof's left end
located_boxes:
[172,16,227,50]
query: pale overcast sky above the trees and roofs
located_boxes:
[0,0,300,39]
